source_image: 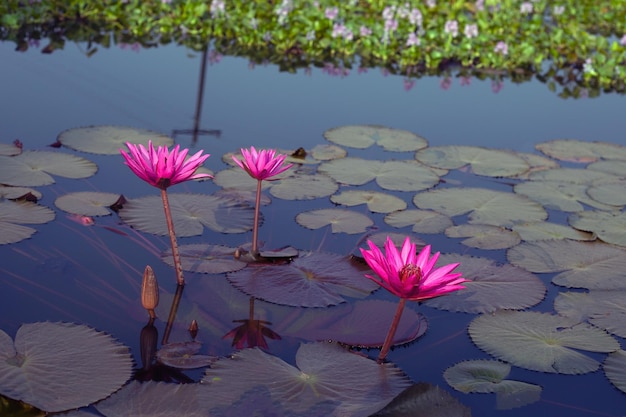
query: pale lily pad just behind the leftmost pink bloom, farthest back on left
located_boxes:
[57,126,174,155]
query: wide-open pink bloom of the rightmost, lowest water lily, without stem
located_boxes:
[361,237,467,301]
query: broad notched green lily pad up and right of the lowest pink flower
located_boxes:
[413,188,548,227]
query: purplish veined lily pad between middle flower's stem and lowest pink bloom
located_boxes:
[228,252,378,307]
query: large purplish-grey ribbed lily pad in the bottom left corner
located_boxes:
[0,322,132,412]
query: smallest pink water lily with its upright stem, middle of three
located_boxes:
[233,146,293,258]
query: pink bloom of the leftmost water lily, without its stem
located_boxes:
[120,141,213,190]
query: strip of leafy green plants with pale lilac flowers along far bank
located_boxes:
[0,0,626,98]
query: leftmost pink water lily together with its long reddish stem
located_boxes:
[120,141,213,286]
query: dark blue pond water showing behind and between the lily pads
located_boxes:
[0,44,626,416]
